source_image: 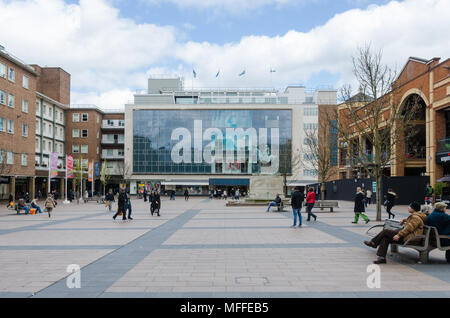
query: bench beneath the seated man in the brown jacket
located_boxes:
[366,220,436,264]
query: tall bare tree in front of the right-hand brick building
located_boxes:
[328,45,422,221]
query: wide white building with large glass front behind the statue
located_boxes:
[125,78,336,195]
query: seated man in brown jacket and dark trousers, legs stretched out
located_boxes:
[364,202,427,264]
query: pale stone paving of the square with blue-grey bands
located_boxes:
[0,198,450,298]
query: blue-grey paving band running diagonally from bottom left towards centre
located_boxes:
[31,209,200,298]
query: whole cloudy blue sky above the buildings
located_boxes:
[0,0,450,109]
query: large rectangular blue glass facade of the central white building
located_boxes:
[133,110,292,174]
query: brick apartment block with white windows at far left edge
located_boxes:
[0,47,38,198]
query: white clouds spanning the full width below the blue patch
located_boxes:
[0,0,450,108]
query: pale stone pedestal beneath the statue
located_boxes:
[249,175,284,200]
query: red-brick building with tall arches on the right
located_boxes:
[337,57,450,185]
